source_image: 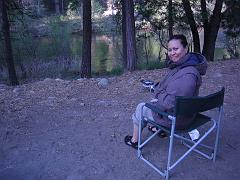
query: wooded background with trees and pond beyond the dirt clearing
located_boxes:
[0,0,240,85]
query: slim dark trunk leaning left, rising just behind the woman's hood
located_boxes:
[182,0,201,53]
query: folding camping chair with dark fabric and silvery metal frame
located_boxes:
[138,88,224,179]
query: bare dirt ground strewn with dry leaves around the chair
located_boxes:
[0,60,240,180]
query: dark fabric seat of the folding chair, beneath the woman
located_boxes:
[148,113,211,133]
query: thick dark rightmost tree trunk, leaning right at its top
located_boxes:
[202,0,223,61]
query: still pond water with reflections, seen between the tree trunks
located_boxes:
[0,34,232,81]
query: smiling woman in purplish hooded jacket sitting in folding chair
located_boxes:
[125,35,207,149]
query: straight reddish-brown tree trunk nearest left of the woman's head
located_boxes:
[124,0,136,71]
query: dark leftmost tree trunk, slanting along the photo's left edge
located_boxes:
[0,0,19,85]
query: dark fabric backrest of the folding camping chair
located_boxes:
[175,87,225,116]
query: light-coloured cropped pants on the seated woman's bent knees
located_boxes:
[132,103,154,128]
